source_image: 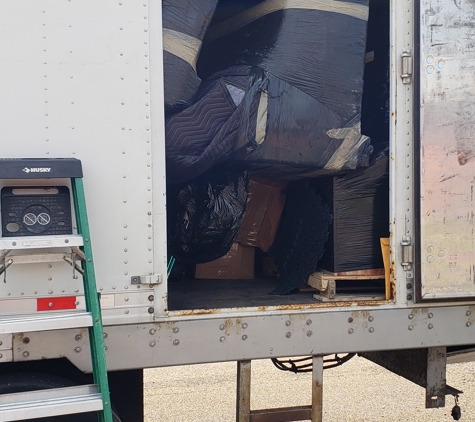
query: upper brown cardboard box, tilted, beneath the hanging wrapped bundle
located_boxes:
[236,179,286,252]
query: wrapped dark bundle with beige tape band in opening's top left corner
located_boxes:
[162,0,218,112]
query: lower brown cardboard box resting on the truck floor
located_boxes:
[195,243,255,280]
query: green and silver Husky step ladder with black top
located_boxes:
[0,159,113,422]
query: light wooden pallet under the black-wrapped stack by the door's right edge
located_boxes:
[307,268,388,302]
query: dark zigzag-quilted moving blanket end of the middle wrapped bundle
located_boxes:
[165,66,250,184]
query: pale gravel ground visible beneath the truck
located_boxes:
[144,357,475,422]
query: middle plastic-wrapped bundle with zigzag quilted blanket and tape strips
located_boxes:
[165,66,372,183]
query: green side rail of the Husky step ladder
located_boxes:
[71,177,112,422]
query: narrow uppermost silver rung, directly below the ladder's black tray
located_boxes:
[0,234,84,250]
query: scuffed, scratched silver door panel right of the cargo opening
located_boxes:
[420,0,475,299]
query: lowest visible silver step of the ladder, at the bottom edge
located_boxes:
[0,384,103,422]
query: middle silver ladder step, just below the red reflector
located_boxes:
[0,312,92,334]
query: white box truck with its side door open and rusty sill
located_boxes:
[0,0,475,422]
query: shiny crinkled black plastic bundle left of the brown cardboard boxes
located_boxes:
[167,167,249,263]
